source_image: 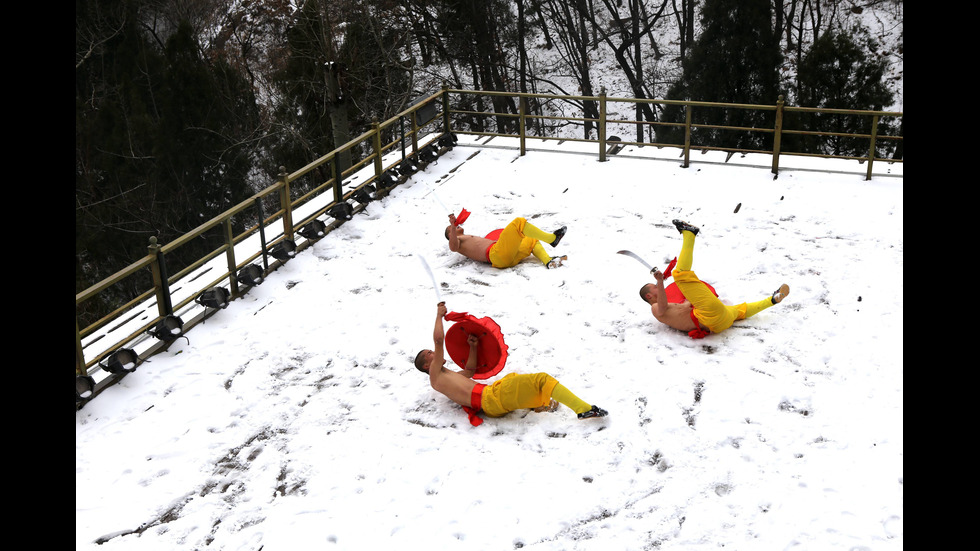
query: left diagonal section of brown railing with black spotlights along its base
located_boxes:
[75,90,448,403]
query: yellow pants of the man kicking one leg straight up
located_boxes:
[672,231,772,333]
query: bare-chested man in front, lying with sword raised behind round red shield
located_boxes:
[415,302,608,426]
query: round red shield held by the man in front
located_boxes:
[445,312,507,379]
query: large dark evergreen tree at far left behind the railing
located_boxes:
[75,4,258,322]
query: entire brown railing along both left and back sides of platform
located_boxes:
[75,87,902,404]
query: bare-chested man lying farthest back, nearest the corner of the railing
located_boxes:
[446,214,568,268]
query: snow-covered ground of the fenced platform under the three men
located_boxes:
[75,136,904,551]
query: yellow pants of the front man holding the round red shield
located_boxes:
[480,373,592,417]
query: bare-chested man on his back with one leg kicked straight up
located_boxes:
[640,220,789,338]
